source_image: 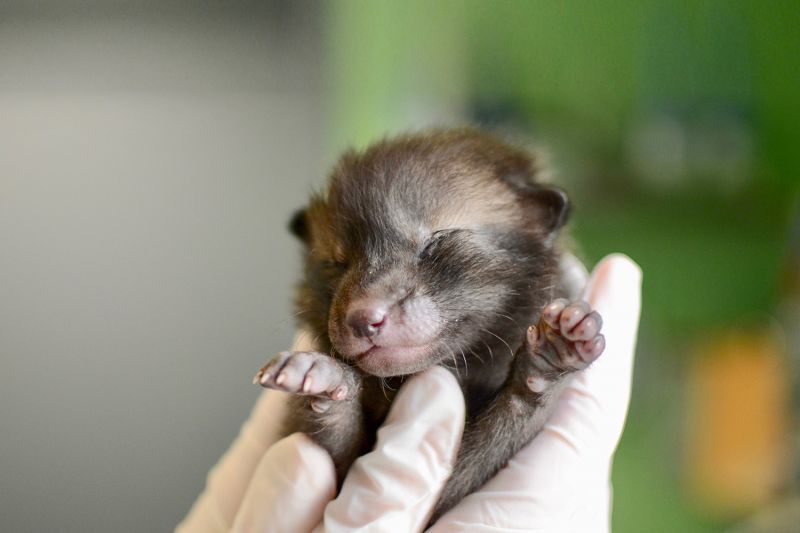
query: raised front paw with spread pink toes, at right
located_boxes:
[522,298,606,392]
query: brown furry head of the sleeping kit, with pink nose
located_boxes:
[296,132,566,376]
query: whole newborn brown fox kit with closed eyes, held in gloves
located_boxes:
[256,129,605,519]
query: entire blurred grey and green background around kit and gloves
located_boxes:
[0,0,800,532]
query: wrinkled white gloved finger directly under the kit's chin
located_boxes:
[317,367,465,533]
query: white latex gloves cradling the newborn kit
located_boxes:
[178,255,641,533]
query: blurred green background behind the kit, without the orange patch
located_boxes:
[325,0,800,532]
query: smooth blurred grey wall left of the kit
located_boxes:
[0,1,325,532]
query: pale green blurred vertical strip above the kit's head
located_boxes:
[324,0,468,158]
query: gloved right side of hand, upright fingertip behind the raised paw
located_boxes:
[432,255,641,531]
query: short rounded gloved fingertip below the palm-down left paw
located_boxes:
[233,433,336,533]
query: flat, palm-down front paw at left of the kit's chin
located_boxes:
[253,352,355,409]
